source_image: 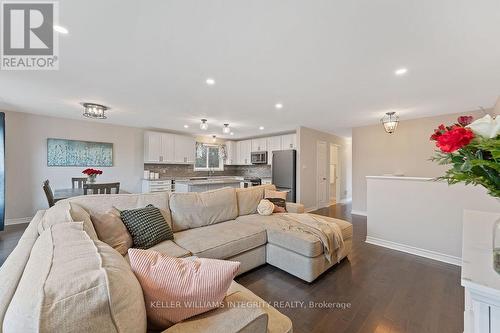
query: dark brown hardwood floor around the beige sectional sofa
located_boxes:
[0,204,464,333]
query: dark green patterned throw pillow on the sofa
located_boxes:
[120,205,174,249]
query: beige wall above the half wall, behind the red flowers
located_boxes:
[352,112,482,212]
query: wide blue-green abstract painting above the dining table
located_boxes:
[47,138,113,167]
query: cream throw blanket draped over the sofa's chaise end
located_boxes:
[274,213,344,263]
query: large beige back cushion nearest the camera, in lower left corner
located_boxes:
[3,222,146,333]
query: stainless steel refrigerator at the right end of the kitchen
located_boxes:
[272,149,297,202]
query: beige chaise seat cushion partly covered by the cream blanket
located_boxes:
[236,214,352,258]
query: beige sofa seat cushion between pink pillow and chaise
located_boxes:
[174,221,267,259]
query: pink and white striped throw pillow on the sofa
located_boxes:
[128,249,240,328]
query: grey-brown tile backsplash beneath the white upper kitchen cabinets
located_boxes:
[144,164,272,179]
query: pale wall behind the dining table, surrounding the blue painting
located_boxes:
[5,112,144,222]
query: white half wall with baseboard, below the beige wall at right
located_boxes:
[367,177,500,264]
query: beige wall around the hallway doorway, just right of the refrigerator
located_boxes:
[297,127,351,210]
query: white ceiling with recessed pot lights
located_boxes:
[0,0,500,138]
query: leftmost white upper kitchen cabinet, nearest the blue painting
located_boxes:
[144,132,174,163]
